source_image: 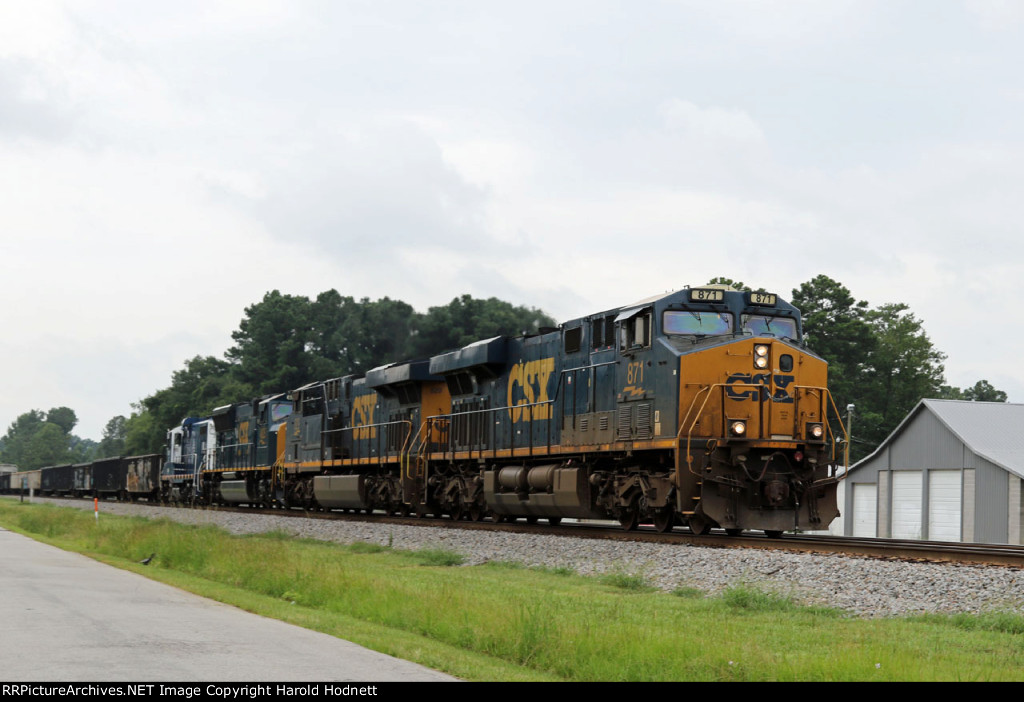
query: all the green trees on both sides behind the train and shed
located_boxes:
[0,275,1007,470]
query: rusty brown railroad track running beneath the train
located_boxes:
[14,495,1024,568]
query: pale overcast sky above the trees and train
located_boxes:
[0,0,1024,440]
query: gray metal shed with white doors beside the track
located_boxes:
[842,400,1024,543]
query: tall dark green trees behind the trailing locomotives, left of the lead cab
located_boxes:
[123,290,555,462]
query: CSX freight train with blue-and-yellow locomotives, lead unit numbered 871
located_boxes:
[4,286,843,536]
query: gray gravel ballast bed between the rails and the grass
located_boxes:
[19,500,1024,617]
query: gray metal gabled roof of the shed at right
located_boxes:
[851,400,1024,478]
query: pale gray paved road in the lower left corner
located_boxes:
[0,528,455,683]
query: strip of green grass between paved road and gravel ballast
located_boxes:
[0,500,1024,682]
